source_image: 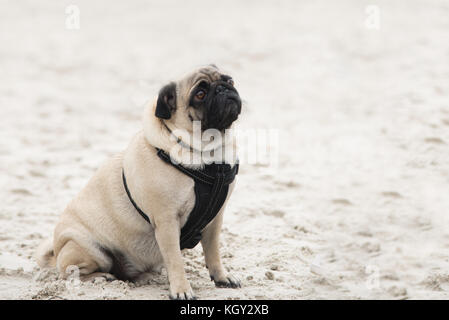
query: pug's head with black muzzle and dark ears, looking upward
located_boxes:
[156,65,242,131]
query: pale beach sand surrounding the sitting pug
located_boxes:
[0,0,449,299]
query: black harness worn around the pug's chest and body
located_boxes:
[122,148,239,250]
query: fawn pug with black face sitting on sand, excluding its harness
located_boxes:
[36,65,242,299]
